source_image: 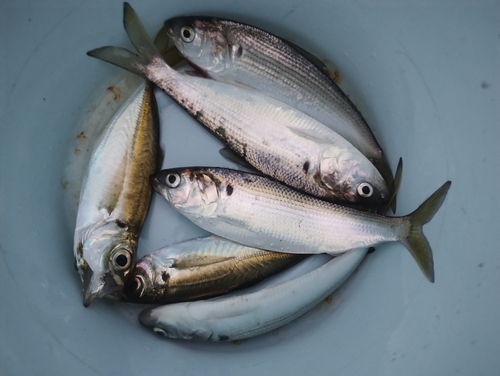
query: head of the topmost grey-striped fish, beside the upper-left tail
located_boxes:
[164,17,232,76]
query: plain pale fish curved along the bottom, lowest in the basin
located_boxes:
[139,248,367,342]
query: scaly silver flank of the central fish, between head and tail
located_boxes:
[201,169,401,254]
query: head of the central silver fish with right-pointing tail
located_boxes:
[151,168,219,218]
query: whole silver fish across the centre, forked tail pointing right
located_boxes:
[151,167,451,282]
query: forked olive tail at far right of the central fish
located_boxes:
[400,181,451,282]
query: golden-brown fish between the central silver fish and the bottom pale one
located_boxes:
[124,236,305,304]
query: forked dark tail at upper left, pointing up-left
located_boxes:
[87,2,166,78]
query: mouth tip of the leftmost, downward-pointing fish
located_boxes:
[83,267,123,307]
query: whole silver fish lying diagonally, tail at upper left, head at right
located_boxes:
[87,3,390,207]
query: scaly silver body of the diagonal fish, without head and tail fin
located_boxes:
[148,62,382,199]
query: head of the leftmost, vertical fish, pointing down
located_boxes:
[76,221,137,307]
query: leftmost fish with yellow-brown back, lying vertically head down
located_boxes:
[74,83,159,306]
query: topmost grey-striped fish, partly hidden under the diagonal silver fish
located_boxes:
[164,16,395,212]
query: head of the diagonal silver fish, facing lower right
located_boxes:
[319,147,389,207]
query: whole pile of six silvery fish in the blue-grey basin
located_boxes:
[74,3,451,341]
